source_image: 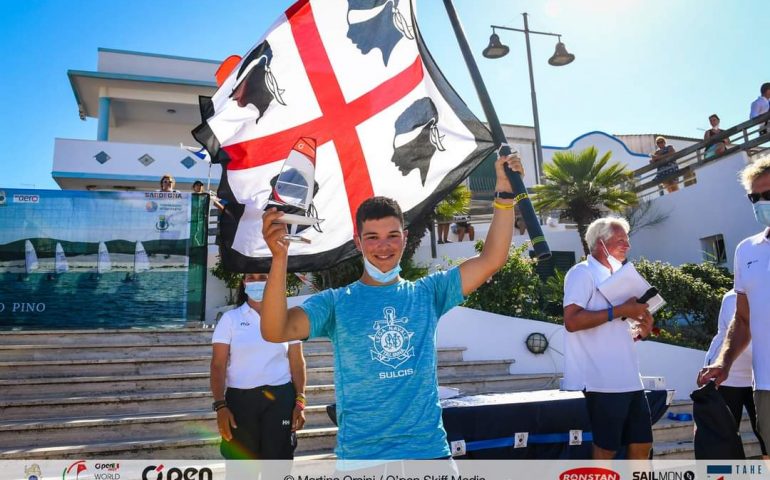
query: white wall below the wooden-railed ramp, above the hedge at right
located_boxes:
[630,153,761,270]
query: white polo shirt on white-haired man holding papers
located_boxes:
[563,255,644,393]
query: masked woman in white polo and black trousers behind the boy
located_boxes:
[211,273,306,460]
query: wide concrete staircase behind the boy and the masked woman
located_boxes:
[0,329,558,460]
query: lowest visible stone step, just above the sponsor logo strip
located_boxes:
[0,428,337,460]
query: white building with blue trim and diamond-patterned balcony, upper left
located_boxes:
[51,48,221,191]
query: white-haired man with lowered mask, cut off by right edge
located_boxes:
[698,156,770,454]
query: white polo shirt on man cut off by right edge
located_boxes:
[733,229,770,390]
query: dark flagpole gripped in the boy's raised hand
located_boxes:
[444,0,551,260]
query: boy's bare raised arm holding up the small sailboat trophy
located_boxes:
[260,208,310,343]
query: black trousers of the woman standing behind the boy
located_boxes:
[219,382,296,460]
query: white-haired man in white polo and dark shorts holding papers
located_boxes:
[564,217,652,460]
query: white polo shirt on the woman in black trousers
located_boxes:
[212,302,299,389]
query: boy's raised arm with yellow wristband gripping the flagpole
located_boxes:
[460,150,524,295]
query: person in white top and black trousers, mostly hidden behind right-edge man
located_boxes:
[703,290,767,455]
